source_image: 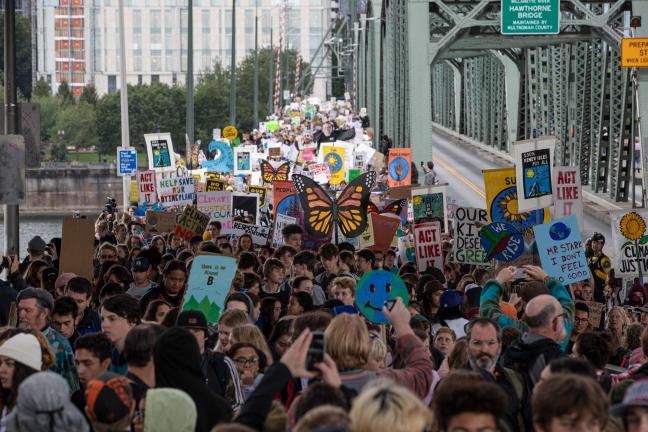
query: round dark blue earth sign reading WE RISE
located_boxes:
[479,222,524,262]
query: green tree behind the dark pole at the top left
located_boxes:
[0,12,32,99]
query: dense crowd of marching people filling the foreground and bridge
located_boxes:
[0,101,648,432]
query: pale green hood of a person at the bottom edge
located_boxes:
[144,388,198,432]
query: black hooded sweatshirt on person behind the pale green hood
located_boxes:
[153,327,232,432]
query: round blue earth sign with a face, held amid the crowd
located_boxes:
[356,270,409,324]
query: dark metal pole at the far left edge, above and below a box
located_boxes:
[3,0,20,255]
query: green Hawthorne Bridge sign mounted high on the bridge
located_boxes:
[501,0,560,35]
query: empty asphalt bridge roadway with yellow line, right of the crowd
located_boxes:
[432,132,611,244]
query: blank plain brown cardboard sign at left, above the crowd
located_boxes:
[59,217,95,280]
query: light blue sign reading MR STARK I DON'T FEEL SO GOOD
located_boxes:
[533,215,591,285]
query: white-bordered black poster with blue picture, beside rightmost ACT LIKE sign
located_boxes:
[513,137,556,211]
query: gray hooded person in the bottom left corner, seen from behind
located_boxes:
[2,372,90,432]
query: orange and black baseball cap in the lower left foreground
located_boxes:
[85,372,134,424]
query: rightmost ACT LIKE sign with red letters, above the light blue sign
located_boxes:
[553,166,583,223]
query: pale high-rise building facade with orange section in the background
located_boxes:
[34,0,331,97]
